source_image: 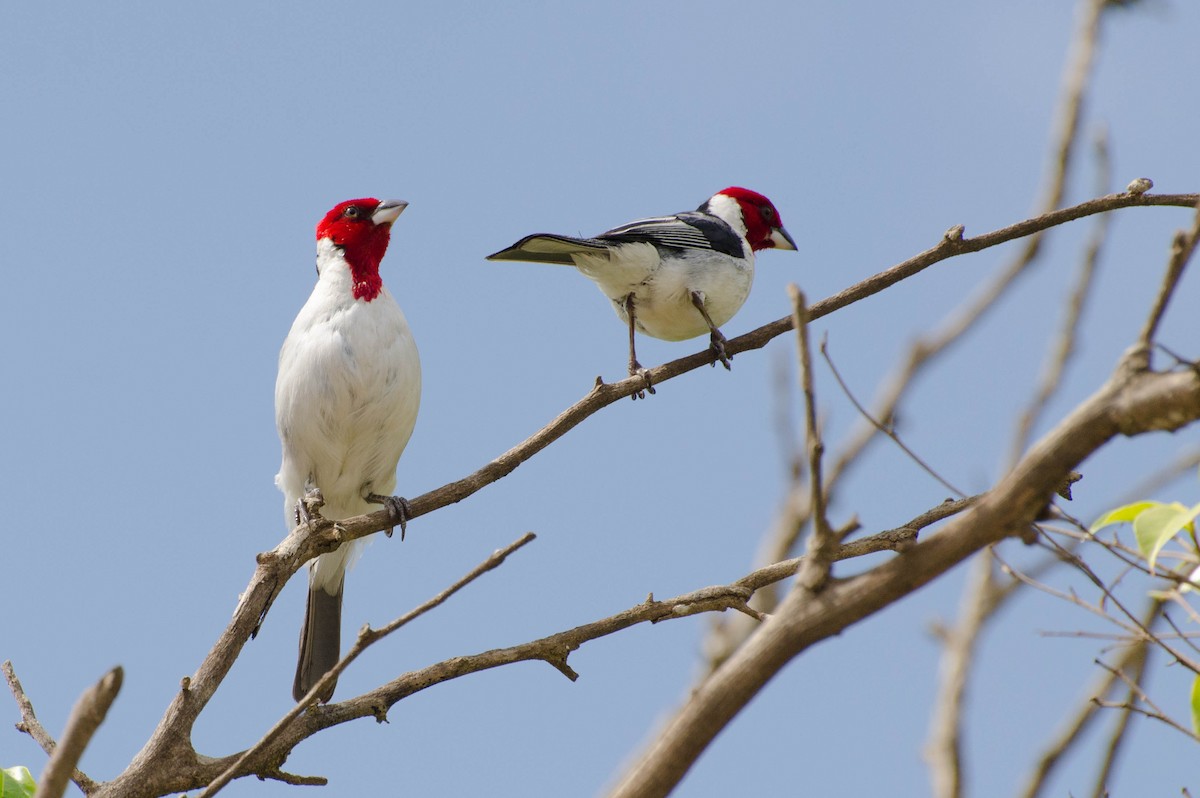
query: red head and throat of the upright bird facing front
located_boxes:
[317,197,408,302]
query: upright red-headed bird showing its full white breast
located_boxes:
[275,198,421,703]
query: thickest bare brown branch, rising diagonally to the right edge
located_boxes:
[611,345,1200,798]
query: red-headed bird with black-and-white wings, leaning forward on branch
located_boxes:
[487,186,796,398]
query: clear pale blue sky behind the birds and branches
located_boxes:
[0,0,1200,797]
